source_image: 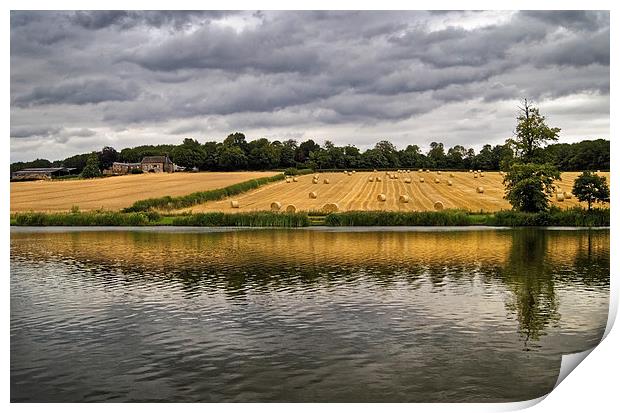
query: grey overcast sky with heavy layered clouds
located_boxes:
[11,11,609,161]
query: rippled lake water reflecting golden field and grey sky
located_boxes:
[10,228,610,402]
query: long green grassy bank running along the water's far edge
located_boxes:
[11,208,610,227]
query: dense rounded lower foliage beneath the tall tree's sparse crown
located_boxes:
[504,163,560,212]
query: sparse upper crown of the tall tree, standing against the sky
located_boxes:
[509,99,560,162]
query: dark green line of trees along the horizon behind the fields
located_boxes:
[11,132,610,173]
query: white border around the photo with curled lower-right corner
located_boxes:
[0,0,620,413]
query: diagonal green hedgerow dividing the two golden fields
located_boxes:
[123,174,284,212]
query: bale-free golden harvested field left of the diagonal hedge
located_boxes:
[11,172,278,212]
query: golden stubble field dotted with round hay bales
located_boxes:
[184,171,609,212]
